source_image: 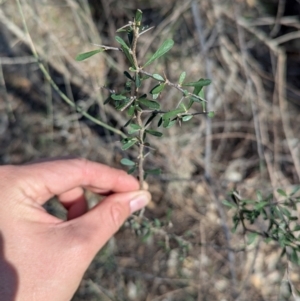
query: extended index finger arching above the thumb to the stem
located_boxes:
[15,159,139,204]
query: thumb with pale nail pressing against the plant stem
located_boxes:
[73,190,151,253]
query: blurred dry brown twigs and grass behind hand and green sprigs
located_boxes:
[0,0,300,301]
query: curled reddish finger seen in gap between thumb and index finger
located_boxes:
[58,187,88,220]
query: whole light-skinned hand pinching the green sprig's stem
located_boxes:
[0,159,150,301]
